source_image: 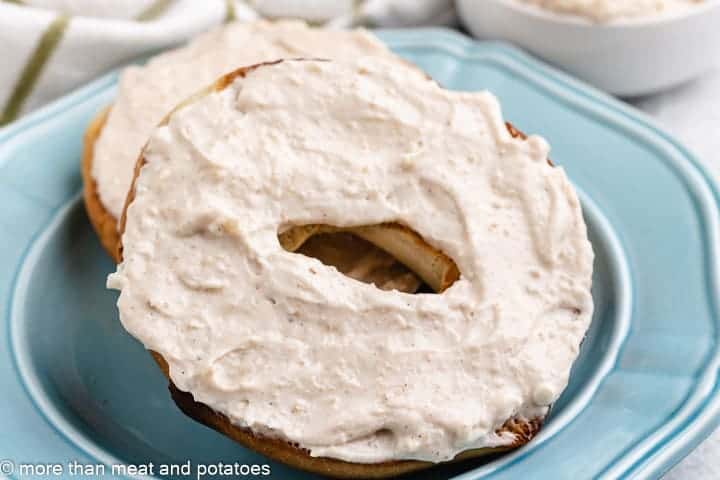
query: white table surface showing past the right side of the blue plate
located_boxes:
[630,65,720,480]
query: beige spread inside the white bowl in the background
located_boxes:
[519,0,704,23]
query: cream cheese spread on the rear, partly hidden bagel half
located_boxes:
[92,21,399,220]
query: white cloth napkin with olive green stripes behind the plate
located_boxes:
[0,0,455,126]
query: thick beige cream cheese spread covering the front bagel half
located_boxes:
[108,57,593,463]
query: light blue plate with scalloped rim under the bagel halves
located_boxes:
[0,29,720,479]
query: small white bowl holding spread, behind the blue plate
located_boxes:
[457,0,720,96]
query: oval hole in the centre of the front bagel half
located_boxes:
[278,224,459,294]
